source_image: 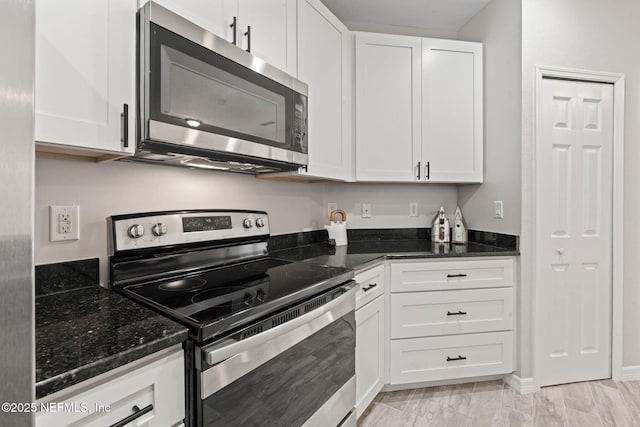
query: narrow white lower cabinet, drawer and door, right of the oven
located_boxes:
[355,265,385,417]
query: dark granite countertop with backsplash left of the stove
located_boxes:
[35,259,187,398]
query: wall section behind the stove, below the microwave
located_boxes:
[34,159,326,284]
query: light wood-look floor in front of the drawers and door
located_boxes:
[358,380,640,427]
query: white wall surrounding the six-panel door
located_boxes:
[521,0,640,376]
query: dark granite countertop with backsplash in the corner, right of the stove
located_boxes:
[270,233,520,270]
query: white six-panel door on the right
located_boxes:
[536,79,613,385]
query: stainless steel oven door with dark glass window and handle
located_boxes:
[195,288,356,427]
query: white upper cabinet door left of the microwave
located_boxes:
[35,0,136,153]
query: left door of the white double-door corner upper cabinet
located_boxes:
[356,33,422,182]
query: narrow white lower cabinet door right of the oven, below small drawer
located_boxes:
[356,296,384,416]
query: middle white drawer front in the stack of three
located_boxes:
[391,288,513,338]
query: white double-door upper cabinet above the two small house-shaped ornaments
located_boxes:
[355,33,483,183]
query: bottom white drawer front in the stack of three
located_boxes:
[390,332,513,384]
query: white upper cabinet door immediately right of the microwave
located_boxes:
[298,0,351,180]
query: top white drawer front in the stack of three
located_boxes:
[391,259,514,292]
